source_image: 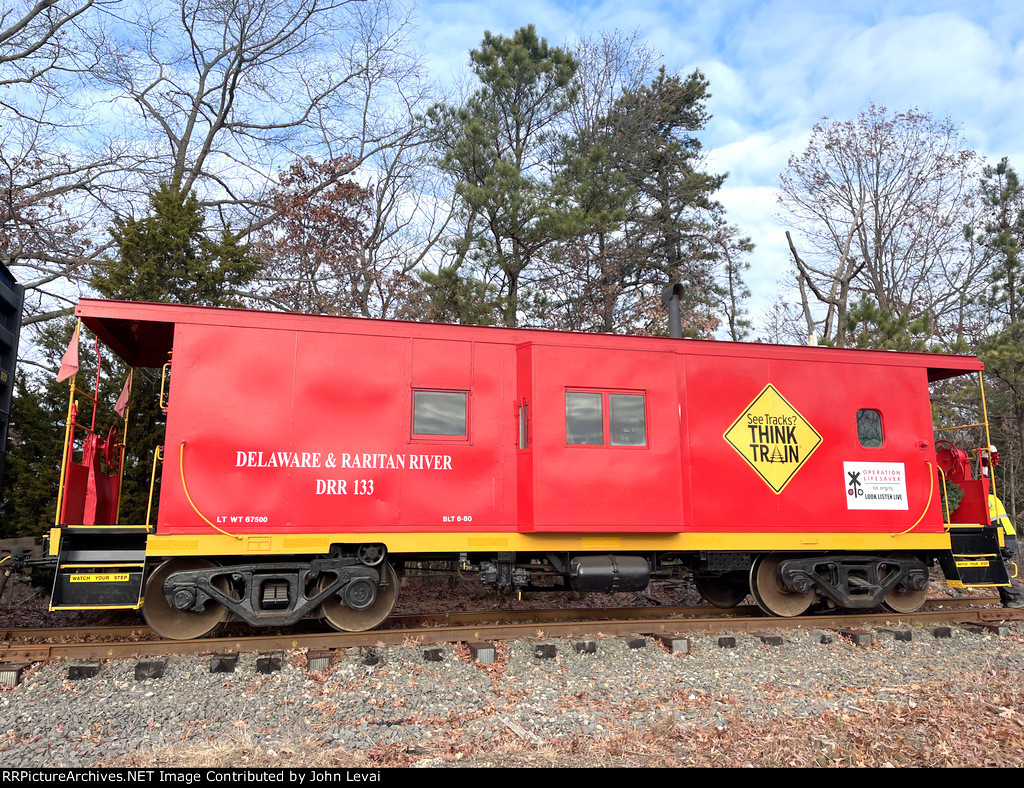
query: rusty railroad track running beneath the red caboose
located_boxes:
[0,598,1024,662]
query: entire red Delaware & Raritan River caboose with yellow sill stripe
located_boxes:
[50,300,1006,638]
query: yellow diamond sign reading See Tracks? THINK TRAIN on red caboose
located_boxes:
[724,384,821,494]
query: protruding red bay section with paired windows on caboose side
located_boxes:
[518,342,682,532]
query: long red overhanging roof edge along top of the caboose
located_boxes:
[75,299,984,381]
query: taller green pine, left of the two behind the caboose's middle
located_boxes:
[430,25,578,325]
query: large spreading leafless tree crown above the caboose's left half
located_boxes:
[84,0,422,229]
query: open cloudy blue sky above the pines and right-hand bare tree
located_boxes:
[407,0,1024,323]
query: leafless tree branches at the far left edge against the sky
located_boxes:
[0,0,132,325]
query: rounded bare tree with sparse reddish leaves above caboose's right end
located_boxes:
[780,104,981,346]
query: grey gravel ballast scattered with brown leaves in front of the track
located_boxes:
[0,624,1024,767]
